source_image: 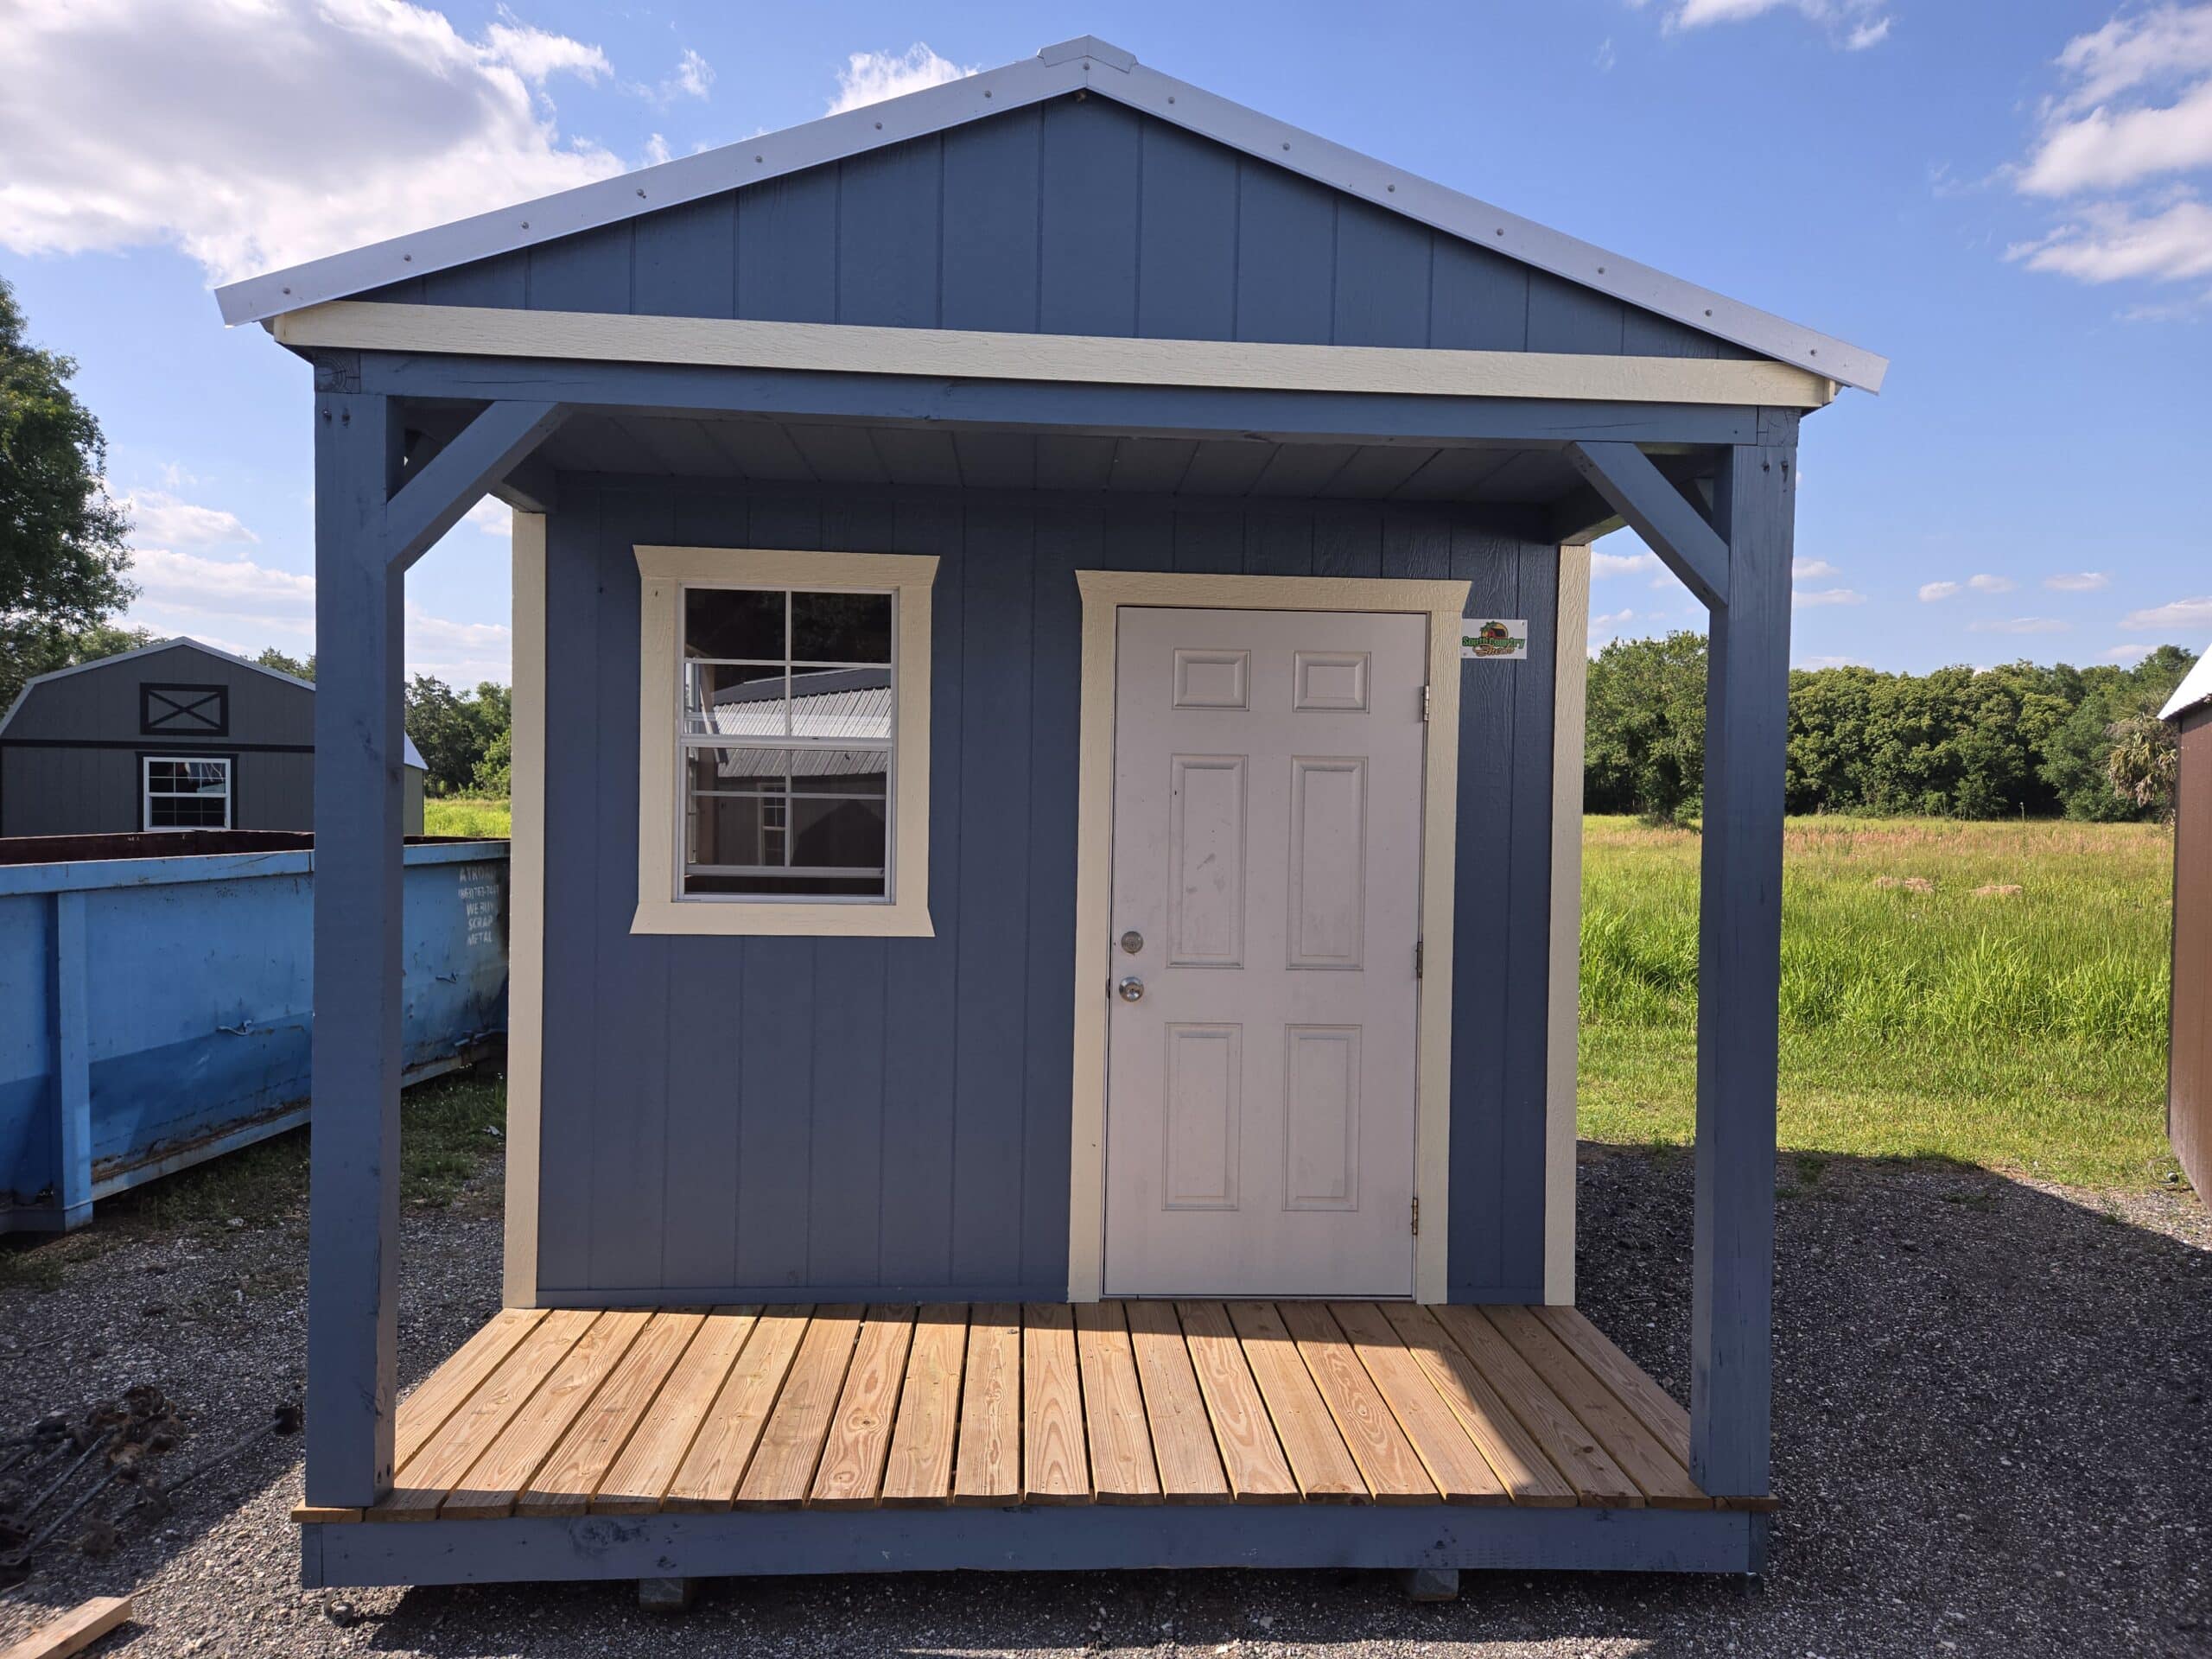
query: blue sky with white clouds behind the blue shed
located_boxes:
[0,0,2212,686]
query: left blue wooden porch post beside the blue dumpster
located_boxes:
[308,391,404,1506]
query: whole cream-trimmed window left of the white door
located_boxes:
[632,546,936,936]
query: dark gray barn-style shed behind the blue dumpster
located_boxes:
[0,637,423,836]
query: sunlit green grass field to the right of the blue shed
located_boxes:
[1581,818,2174,1185]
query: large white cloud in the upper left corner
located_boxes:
[0,0,621,281]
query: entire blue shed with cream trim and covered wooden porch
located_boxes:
[221,38,1885,1584]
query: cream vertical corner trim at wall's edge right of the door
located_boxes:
[1544,546,1591,1305]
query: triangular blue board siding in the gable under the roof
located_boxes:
[363,98,1757,359]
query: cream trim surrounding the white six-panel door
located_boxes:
[1068,570,1469,1303]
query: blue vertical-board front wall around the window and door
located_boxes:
[540,475,1557,1300]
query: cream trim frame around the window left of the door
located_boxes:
[631,546,938,938]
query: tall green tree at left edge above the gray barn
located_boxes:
[0,270,133,708]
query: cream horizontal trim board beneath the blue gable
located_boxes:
[272,299,1836,410]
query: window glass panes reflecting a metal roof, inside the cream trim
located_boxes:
[679,588,896,900]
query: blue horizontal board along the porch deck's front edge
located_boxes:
[301,1504,1767,1588]
